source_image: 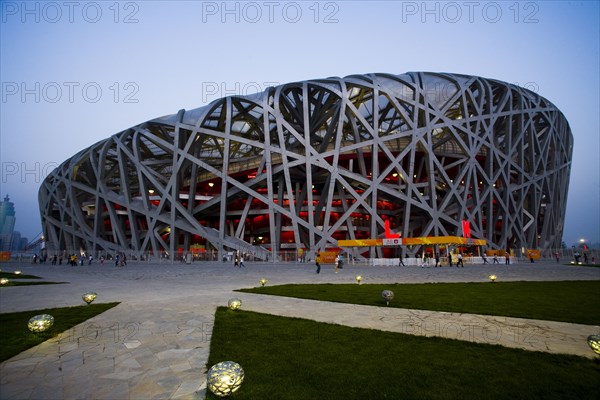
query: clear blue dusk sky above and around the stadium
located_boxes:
[0,1,600,246]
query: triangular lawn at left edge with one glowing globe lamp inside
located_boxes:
[0,303,119,361]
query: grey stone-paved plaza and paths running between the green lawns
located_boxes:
[0,262,600,400]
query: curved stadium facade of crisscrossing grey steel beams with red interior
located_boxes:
[39,73,573,256]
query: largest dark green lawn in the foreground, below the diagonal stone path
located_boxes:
[206,307,600,400]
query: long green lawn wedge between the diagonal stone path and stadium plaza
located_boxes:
[240,281,600,325]
